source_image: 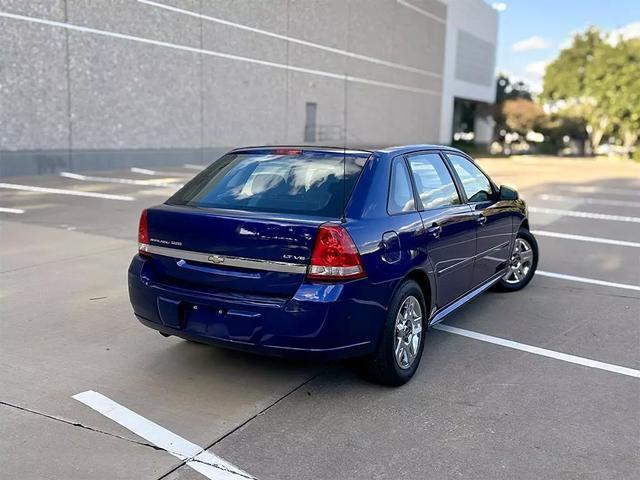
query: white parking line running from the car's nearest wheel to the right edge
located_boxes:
[433,323,640,378]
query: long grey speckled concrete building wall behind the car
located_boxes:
[0,0,496,176]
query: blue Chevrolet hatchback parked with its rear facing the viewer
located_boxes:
[128,145,538,385]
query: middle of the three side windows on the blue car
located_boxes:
[409,153,461,209]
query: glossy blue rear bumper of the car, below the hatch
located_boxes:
[128,255,392,360]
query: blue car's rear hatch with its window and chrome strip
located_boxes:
[142,150,366,298]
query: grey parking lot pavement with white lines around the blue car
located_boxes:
[0,157,640,480]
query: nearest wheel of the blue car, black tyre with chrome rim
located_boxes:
[360,280,428,387]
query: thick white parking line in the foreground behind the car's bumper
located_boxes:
[72,390,255,480]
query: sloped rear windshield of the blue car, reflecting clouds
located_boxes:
[167,151,368,218]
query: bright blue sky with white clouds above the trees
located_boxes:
[487,0,640,92]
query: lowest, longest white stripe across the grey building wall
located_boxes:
[0,12,441,96]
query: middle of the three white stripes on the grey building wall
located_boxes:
[138,0,442,78]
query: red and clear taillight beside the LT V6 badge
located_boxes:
[307,224,365,281]
